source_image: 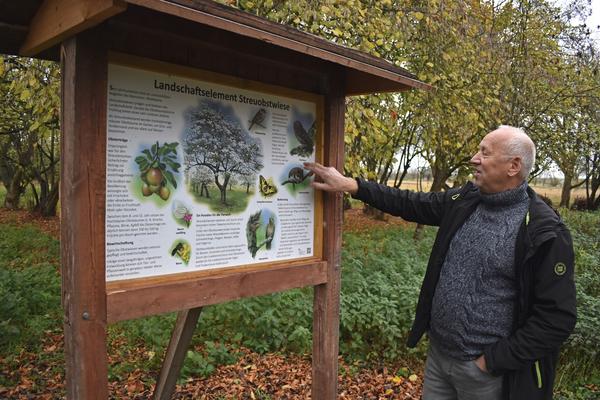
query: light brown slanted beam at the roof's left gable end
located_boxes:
[19,0,127,57]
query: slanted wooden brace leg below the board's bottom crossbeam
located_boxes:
[152,307,202,400]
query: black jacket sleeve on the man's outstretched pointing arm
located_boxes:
[352,179,460,226]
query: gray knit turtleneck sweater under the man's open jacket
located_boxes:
[429,182,529,360]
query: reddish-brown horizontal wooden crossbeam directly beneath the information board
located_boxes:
[107,261,327,323]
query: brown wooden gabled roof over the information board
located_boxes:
[0,0,431,95]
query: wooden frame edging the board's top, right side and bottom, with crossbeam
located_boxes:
[106,53,326,323]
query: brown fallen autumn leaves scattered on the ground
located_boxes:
[0,209,422,400]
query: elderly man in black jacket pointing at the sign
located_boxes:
[305,126,576,400]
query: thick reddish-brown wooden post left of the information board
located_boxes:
[60,31,108,400]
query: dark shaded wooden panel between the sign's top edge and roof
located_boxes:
[107,6,328,93]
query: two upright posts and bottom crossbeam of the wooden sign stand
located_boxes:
[61,25,344,399]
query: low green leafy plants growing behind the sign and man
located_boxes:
[0,210,600,400]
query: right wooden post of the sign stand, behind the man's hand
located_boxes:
[312,71,345,400]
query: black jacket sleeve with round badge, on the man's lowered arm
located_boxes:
[484,225,577,375]
